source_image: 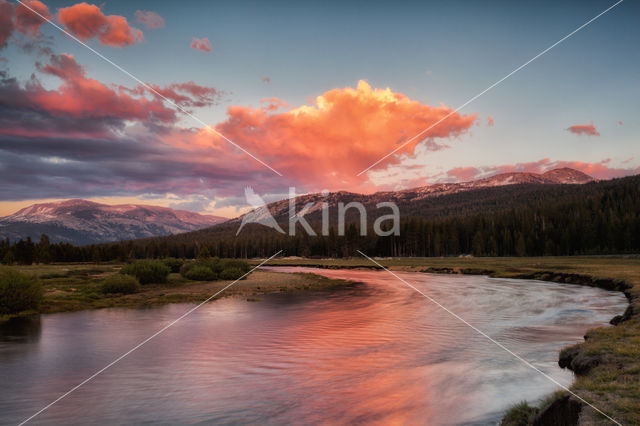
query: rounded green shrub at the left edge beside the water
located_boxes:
[0,268,44,315]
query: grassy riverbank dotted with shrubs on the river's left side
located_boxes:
[2,264,351,313]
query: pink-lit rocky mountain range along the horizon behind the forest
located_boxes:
[0,168,593,245]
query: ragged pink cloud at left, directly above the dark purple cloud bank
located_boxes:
[0,54,223,141]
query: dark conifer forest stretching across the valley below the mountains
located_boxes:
[0,177,640,263]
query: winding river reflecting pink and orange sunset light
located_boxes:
[0,268,627,425]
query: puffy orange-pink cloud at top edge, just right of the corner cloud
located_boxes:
[58,2,144,47]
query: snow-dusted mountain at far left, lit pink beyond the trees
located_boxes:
[0,199,226,245]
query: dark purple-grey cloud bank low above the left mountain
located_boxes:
[0,132,282,201]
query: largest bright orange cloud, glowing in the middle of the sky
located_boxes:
[165,81,476,189]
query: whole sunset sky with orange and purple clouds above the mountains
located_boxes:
[0,0,640,217]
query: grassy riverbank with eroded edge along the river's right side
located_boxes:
[262,256,640,425]
